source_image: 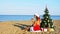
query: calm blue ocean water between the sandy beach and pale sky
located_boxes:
[0,15,60,21]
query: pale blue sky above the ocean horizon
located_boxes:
[0,0,60,15]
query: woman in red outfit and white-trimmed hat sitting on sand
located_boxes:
[31,13,40,32]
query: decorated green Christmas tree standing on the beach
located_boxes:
[41,7,54,28]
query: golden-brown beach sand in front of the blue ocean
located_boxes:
[0,20,60,34]
